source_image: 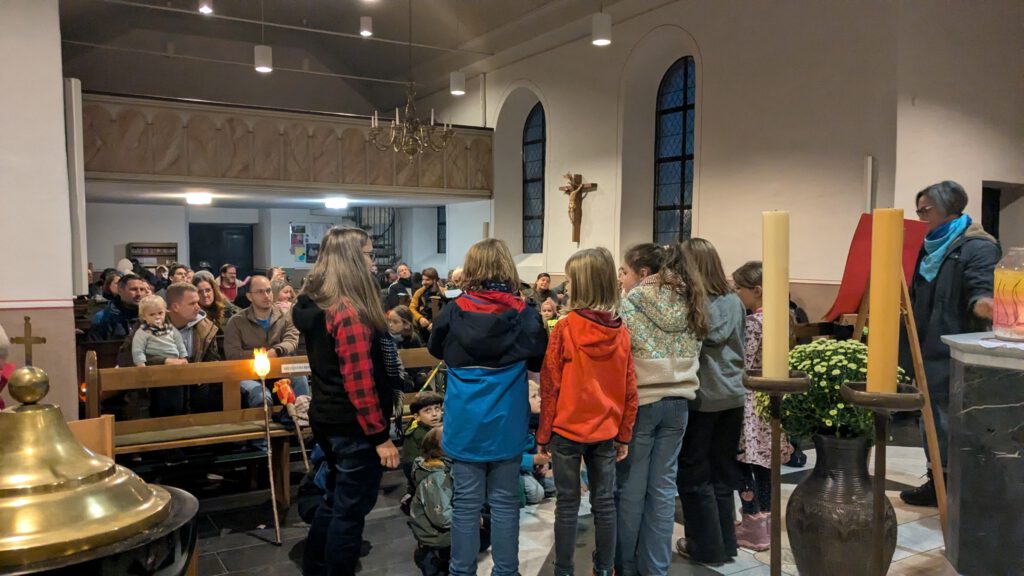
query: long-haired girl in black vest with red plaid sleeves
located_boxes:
[292,228,401,575]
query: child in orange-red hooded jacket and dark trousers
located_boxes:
[537,248,637,576]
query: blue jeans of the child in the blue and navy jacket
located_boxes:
[452,455,521,576]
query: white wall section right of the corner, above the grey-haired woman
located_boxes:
[896,0,1024,219]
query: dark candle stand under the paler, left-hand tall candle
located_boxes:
[743,370,811,576]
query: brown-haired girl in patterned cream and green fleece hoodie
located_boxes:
[615,244,708,576]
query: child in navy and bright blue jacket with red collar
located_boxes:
[428,239,547,576]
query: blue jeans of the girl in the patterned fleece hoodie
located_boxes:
[615,398,689,576]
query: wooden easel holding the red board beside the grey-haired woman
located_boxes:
[853,274,948,539]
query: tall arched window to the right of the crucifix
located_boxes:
[654,56,696,245]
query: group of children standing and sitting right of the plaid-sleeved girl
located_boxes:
[296,228,786,576]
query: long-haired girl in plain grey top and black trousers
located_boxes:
[674,238,746,565]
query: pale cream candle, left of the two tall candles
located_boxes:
[761,211,790,378]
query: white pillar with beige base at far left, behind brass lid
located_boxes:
[0,0,78,412]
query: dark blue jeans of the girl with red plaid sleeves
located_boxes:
[302,430,384,576]
